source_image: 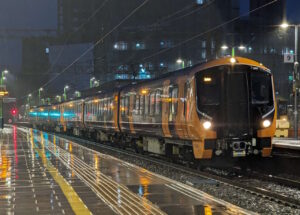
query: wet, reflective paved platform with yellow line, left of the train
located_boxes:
[0,126,251,215]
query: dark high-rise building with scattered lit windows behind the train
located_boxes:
[58,0,293,97]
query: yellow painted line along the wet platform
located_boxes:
[32,132,92,215]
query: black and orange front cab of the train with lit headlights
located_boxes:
[187,58,276,159]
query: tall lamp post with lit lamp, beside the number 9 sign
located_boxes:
[280,22,300,139]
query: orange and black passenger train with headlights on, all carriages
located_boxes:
[28,57,276,160]
